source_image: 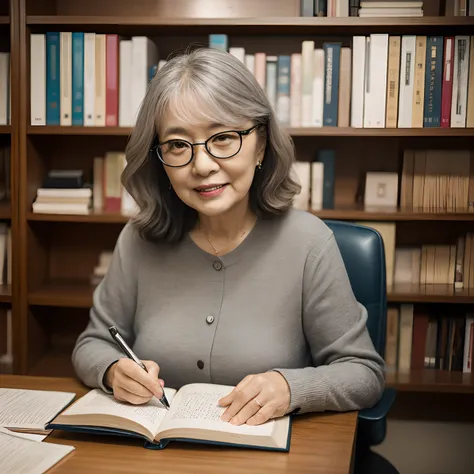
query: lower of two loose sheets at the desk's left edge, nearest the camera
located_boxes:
[0,428,74,474]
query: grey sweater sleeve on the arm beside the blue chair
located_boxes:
[276,233,385,413]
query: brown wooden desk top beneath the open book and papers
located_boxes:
[0,375,357,474]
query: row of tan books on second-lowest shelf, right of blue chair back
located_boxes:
[392,232,474,291]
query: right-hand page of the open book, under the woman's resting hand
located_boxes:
[161,383,274,436]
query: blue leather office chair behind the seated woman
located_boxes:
[325,220,398,474]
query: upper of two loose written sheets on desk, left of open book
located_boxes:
[0,388,76,430]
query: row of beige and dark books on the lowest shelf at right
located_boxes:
[385,304,474,373]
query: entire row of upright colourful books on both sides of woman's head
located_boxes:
[30,27,474,128]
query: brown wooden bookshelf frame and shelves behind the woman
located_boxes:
[0,0,474,410]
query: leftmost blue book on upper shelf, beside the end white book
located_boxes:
[46,32,61,125]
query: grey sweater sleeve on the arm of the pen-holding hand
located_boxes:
[72,224,138,391]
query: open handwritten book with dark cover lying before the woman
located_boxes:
[48,383,291,451]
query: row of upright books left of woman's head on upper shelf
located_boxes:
[30,32,158,127]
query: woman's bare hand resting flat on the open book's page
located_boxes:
[219,372,290,425]
